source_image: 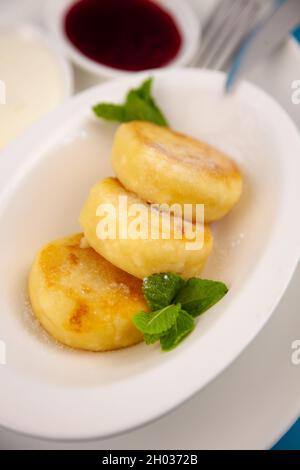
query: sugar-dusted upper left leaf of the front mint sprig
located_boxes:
[143,273,184,310]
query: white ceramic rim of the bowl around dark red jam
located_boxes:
[44,0,200,78]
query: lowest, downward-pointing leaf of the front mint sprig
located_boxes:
[160,310,195,351]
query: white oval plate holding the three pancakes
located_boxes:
[0,69,300,439]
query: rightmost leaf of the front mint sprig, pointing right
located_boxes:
[175,278,228,317]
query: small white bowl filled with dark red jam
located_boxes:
[45,0,200,78]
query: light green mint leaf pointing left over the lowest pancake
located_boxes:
[133,305,180,335]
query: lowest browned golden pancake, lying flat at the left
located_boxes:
[29,234,147,351]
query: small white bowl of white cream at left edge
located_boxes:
[0,24,73,150]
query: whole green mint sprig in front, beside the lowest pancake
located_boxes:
[133,273,228,351]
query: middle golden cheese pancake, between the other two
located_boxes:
[80,178,212,279]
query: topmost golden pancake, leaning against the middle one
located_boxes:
[112,121,242,222]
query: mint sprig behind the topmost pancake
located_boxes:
[93,78,168,126]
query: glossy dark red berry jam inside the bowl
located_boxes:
[65,0,182,71]
